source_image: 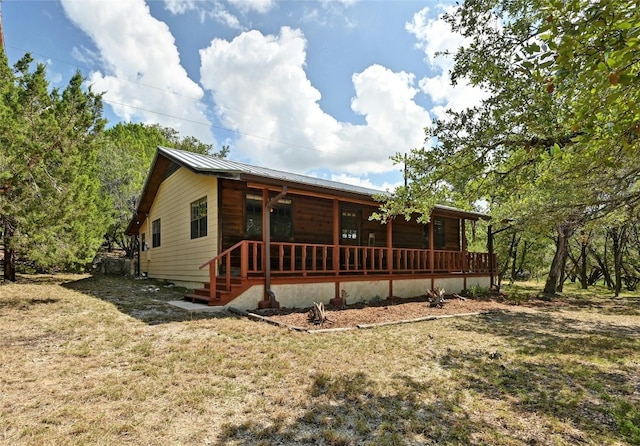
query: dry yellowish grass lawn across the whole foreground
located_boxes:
[0,276,640,445]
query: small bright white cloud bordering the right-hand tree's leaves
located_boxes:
[406,7,486,118]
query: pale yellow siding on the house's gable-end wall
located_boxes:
[141,167,218,285]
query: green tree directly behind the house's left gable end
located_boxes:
[99,123,229,256]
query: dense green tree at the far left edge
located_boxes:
[0,53,110,280]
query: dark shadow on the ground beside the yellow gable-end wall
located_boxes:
[62,275,237,325]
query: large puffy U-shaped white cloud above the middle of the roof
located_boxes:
[200,27,429,175]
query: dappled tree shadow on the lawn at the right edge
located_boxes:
[440,313,640,444]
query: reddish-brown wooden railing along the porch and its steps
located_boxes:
[200,240,491,297]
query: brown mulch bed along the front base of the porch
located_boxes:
[253,298,512,329]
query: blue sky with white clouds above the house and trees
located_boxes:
[0,0,482,190]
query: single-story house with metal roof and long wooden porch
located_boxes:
[127,147,495,309]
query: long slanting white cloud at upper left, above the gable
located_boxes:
[62,0,213,143]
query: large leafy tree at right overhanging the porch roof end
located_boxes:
[382,0,640,294]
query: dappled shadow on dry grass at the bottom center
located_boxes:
[216,373,516,446]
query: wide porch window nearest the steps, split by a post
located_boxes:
[245,194,293,240]
